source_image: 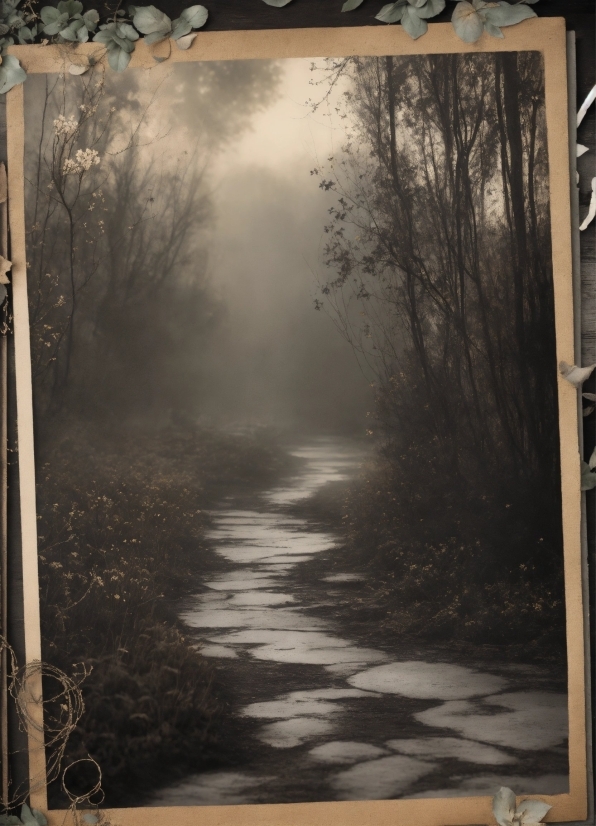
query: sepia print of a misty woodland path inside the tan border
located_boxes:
[9,22,584,822]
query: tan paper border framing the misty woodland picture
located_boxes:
[7,18,587,826]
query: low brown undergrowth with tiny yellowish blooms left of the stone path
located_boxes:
[38,421,292,805]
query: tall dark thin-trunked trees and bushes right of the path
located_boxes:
[313,54,564,646]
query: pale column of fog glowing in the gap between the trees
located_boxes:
[186,60,370,432]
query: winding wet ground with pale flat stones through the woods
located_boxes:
[151,440,568,806]
